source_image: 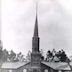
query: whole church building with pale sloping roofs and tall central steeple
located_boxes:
[0,6,72,72]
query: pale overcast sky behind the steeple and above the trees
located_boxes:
[1,0,72,55]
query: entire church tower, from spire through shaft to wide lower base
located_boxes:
[31,3,41,72]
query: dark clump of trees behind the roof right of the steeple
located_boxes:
[46,49,70,62]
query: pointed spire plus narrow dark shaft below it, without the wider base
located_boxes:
[32,1,39,52]
